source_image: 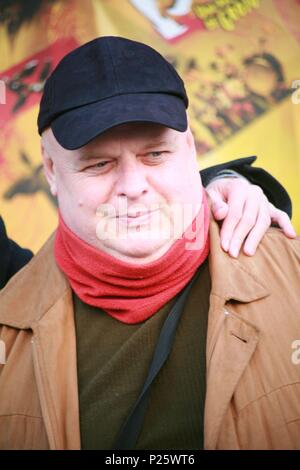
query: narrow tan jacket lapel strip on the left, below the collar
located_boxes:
[33,290,80,450]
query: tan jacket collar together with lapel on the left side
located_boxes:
[0,237,80,449]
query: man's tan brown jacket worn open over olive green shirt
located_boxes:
[0,222,300,449]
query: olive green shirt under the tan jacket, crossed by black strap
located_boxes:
[74,261,211,449]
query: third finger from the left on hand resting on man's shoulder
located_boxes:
[228,197,262,258]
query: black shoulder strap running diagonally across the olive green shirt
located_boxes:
[114,271,199,450]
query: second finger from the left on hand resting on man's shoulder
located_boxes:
[220,186,246,251]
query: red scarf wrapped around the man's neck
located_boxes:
[54,190,209,324]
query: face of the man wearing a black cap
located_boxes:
[43,123,202,263]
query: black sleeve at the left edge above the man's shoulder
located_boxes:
[0,217,33,289]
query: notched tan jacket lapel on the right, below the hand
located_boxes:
[204,222,269,449]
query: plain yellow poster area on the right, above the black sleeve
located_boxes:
[199,100,300,217]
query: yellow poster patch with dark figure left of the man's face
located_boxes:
[0,106,57,252]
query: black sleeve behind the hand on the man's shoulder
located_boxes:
[200,157,292,217]
